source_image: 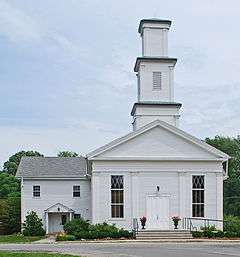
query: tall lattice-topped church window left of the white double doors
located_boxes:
[111,175,124,218]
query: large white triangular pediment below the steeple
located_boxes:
[89,121,228,159]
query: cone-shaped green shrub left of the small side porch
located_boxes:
[23,211,45,236]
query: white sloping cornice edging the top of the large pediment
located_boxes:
[87,120,230,160]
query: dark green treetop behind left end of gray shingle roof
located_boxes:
[3,151,43,175]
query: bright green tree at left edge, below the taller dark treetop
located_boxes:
[0,172,20,198]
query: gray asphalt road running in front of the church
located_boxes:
[0,243,240,257]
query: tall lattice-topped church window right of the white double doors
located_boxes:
[192,175,205,217]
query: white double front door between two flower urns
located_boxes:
[146,196,170,230]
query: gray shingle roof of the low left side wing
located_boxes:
[16,157,87,178]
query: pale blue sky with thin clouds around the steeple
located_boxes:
[0,0,240,167]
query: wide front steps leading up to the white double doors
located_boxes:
[136,230,192,240]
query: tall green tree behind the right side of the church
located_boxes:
[206,136,240,216]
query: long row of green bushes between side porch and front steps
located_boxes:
[64,219,132,239]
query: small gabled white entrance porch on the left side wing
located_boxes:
[44,203,74,234]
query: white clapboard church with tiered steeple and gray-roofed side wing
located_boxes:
[16,19,229,233]
